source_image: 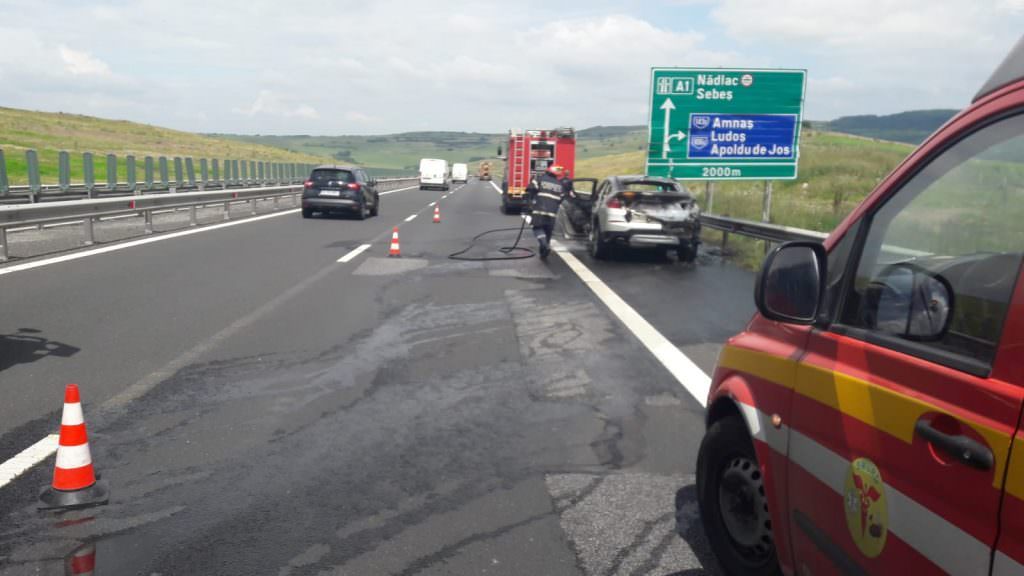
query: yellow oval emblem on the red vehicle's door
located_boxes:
[843,458,889,558]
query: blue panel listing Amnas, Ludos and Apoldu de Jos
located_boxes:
[686,113,798,160]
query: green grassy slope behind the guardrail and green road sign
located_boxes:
[577,129,913,268]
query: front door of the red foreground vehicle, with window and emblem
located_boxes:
[787,109,1024,575]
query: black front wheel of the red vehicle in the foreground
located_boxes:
[697,417,781,576]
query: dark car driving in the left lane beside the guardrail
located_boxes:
[302,166,381,220]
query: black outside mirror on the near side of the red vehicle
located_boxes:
[754,242,828,325]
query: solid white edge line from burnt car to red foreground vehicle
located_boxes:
[551,240,711,406]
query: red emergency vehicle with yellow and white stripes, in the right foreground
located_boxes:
[697,39,1024,576]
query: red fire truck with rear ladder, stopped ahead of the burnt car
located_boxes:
[502,128,575,214]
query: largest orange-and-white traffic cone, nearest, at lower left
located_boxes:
[39,384,110,510]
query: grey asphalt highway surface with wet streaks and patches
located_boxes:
[0,180,753,575]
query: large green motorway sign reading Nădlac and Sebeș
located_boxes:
[647,68,806,180]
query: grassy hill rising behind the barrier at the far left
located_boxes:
[0,108,326,184]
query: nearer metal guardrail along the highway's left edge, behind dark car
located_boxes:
[0,177,418,262]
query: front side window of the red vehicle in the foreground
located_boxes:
[842,116,1024,367]
